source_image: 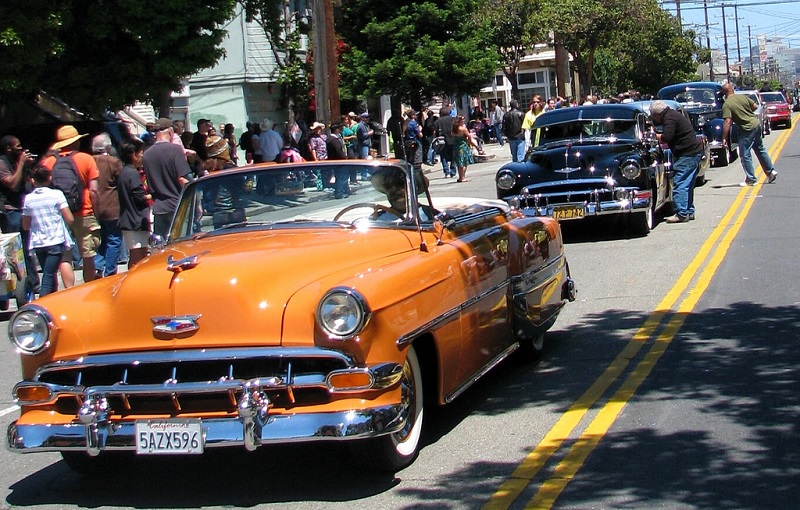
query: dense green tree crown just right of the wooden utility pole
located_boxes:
[337,0,499,108]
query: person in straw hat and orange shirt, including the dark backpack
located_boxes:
[42,124,101,282]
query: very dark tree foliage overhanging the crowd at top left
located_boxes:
[0,0,236,115]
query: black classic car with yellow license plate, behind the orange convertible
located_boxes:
[495,103,672,235]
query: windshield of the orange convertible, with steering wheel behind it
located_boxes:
[170,162,434,241]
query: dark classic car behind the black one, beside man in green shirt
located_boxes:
[658,81,738,166]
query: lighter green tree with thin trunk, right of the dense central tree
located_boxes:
[482,0,549,97]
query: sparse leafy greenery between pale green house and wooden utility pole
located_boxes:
[238,0,314,120]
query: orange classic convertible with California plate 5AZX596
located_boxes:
[7,161,575,471]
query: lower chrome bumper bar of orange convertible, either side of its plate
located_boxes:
[7,404,408,455]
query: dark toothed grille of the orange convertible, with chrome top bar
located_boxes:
[36,348,353,416]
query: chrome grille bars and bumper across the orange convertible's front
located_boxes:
[7,348,410,455]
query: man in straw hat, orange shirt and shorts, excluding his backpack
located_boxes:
[42,124,101,282]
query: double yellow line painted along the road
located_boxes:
[483,116,797,510]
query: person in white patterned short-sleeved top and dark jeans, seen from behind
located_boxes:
[22,165,73,296]
